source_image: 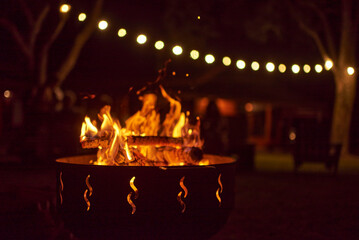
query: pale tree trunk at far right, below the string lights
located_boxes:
[330,68,356,154]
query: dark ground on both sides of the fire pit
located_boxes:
[0,152,359,240]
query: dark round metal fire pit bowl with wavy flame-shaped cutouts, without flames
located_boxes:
[56,155,235,239]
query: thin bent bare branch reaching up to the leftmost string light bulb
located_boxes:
[38,9,69,85]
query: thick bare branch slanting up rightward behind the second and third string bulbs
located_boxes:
[55,0,103,87]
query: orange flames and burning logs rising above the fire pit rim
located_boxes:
[80,85,205,166]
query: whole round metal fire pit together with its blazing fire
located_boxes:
[57,71,235,239]
